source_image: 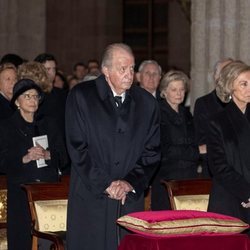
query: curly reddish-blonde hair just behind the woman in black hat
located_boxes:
[17,61,53,93]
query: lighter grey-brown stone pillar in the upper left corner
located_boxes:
[0,0,46,60]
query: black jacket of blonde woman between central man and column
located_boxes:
[160,100,199,174]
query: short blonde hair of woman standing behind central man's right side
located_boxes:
[159,70,189,98]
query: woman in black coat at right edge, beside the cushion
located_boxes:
[208,62,250,226]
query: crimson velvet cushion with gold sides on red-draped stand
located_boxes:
[117,210,249,237]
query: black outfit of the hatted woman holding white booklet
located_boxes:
[0,111,67,250]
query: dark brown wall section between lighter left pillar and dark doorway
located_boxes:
[46,0,122,74]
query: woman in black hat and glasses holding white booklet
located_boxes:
[0,79,67,250]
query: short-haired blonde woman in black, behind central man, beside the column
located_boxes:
[151,70,199,210]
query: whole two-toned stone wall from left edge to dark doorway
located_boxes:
[0,0,122,73]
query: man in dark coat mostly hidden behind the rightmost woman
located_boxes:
[194,58,233,177]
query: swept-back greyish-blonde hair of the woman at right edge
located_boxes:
[215,61,250,103]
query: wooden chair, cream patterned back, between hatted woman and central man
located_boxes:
[22,176,69,250]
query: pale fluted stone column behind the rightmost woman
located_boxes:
[191,0,250,110]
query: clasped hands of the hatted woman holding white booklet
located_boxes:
[23,144,50,163]
